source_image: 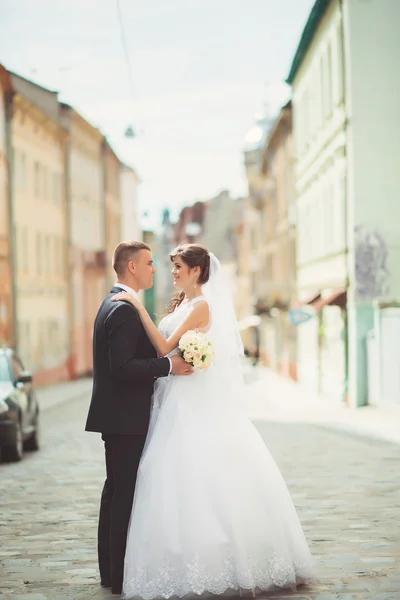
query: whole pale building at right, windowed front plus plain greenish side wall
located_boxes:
[288,0,400,406]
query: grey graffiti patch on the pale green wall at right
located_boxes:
[354,225,390,300]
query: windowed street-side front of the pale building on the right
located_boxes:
[289,0,347,402]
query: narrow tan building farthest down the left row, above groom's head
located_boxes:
[103,139,122,290]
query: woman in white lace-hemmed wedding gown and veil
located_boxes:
[114,244,313,600]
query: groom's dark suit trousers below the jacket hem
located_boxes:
[98,434,146,591]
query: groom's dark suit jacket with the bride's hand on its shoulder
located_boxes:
[86,286,170,435]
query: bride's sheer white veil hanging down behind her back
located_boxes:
[203,252,244,393]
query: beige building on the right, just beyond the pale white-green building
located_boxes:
[236,102,296,379]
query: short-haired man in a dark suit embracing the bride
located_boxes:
[86,242,192,594]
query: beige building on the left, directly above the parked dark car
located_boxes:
[11,74,69,385]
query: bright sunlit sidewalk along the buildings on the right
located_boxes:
[246,367,400,444]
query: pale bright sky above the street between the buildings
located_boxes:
[0,0,314,223]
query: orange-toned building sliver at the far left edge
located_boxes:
[0,65,14,345]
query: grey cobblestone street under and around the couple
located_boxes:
[0,384,400,600]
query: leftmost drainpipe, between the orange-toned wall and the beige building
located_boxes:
[4,90,18,351]
